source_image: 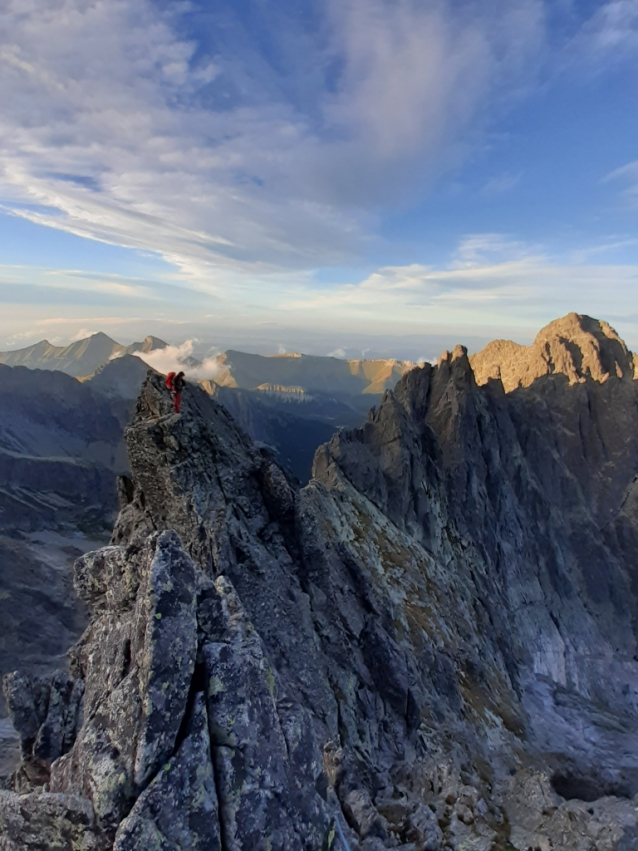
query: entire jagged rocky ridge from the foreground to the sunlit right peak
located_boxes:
[0,314,638,851]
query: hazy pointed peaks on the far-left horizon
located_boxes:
[0,332,166,378]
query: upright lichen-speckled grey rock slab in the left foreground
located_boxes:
[50,532,197,830]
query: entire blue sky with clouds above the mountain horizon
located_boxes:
[0,0,638,359]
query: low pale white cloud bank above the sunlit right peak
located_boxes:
[281,234,638,339]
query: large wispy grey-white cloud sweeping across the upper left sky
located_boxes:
[0,0,544,282]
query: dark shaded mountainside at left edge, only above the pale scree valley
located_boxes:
[0,365,127,530]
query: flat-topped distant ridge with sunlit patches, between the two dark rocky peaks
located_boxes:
[214,349,414,395]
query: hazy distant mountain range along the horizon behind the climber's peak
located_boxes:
[0,333,414,490]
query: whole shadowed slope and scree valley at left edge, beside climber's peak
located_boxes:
[0,365,132,732]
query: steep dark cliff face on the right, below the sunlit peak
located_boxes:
[317,342,638,794]
